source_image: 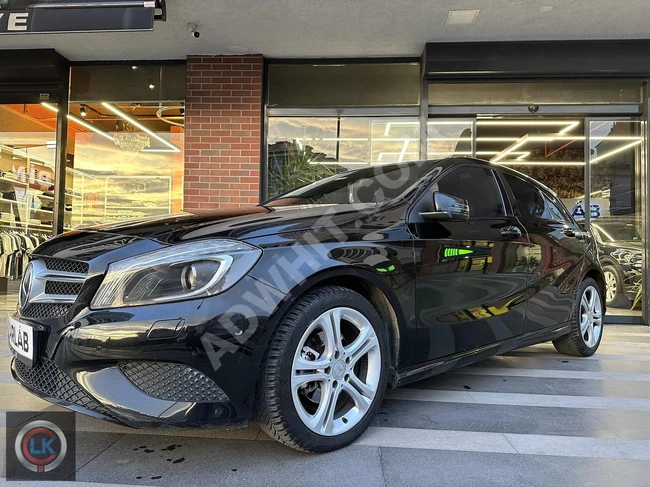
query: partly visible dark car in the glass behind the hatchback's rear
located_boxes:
[591,216,643,309]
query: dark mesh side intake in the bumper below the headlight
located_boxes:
[119,362,228,402]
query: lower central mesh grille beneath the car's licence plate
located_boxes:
[14,357,105,413]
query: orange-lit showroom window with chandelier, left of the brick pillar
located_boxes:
[57,64,185,228]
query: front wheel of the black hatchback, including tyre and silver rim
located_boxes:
[255,286,390,452]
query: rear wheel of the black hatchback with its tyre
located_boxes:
[553,277,604,357]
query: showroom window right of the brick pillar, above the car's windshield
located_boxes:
[265,62,420,197]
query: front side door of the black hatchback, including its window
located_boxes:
[409,165,528,363]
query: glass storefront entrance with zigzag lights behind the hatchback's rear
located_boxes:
[427,112,645,323]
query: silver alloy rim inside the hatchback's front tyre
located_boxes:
[291,307,381,436]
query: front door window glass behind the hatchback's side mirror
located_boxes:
[433,166,505,218]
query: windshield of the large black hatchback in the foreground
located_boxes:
[264,161,436,206]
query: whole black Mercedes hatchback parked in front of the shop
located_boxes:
[10,159,605,452]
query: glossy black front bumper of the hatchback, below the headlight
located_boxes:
[12,277,281,428]
